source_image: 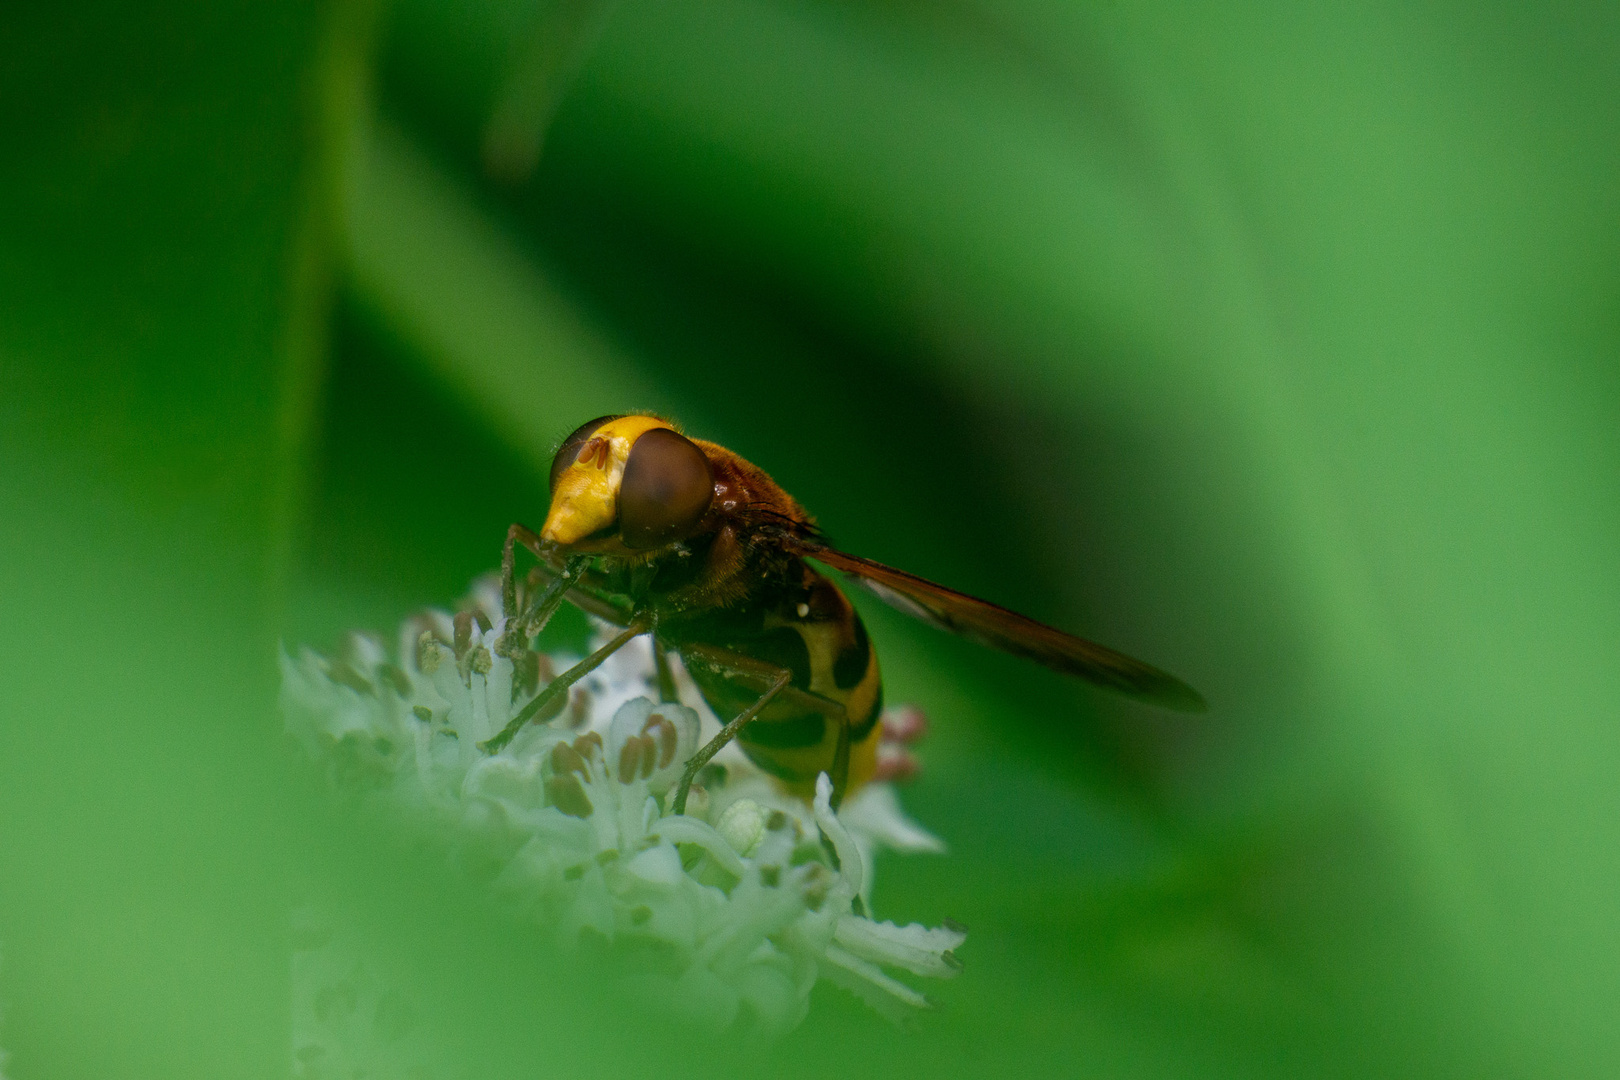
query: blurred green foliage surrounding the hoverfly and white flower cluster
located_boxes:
[0,0,1620,1080]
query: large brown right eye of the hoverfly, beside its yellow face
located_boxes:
[619,427,714,551]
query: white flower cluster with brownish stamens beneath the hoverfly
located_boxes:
[282,585,964,1036]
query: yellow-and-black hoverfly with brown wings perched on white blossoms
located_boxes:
[483,415,1204,813]
